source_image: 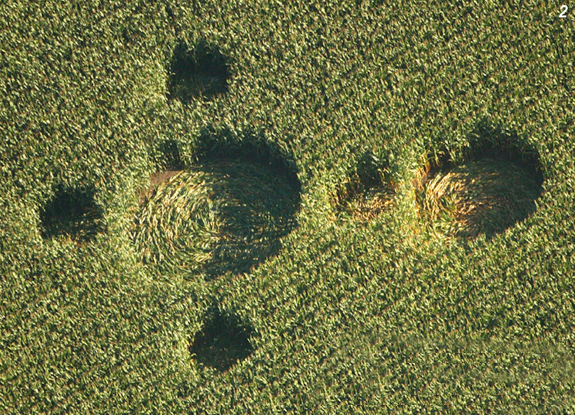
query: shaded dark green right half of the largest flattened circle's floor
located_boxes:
[200,161,299,279]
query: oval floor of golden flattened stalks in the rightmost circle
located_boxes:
[422,157,541,238]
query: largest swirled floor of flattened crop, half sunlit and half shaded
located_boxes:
[135,160,299,279]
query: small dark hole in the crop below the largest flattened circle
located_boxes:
[189,310,253,372]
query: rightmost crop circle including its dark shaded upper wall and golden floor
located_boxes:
[417,122,543,239]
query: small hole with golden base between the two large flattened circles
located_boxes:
[334,152,395,221]
